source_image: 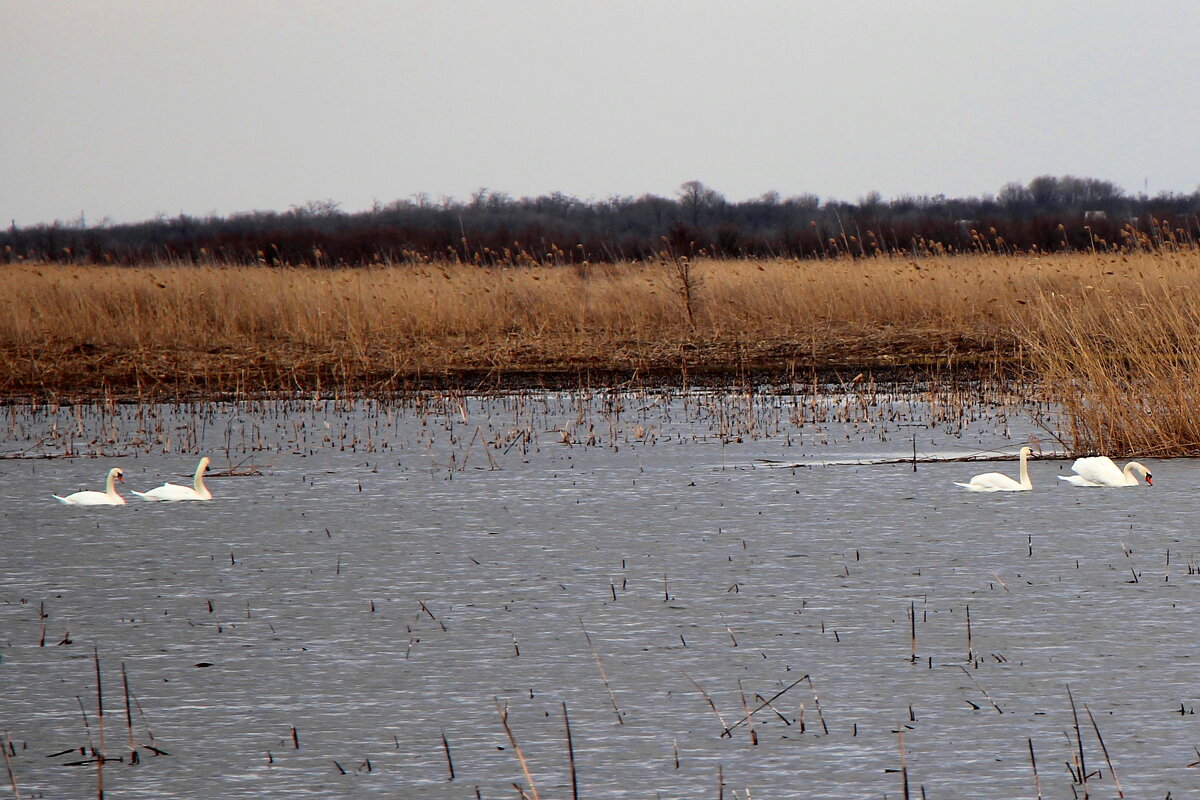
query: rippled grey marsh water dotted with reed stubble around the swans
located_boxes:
[0,393,1200,799]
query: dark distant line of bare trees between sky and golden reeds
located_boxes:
[0,175,1200,266]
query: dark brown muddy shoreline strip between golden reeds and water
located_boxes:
[0,342,1018,403]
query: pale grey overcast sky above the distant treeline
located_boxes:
[0,0,1200,225]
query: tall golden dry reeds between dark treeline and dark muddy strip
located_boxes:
[0,254,1142,367]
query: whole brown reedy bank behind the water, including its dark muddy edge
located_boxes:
[0,251,1200,407]
